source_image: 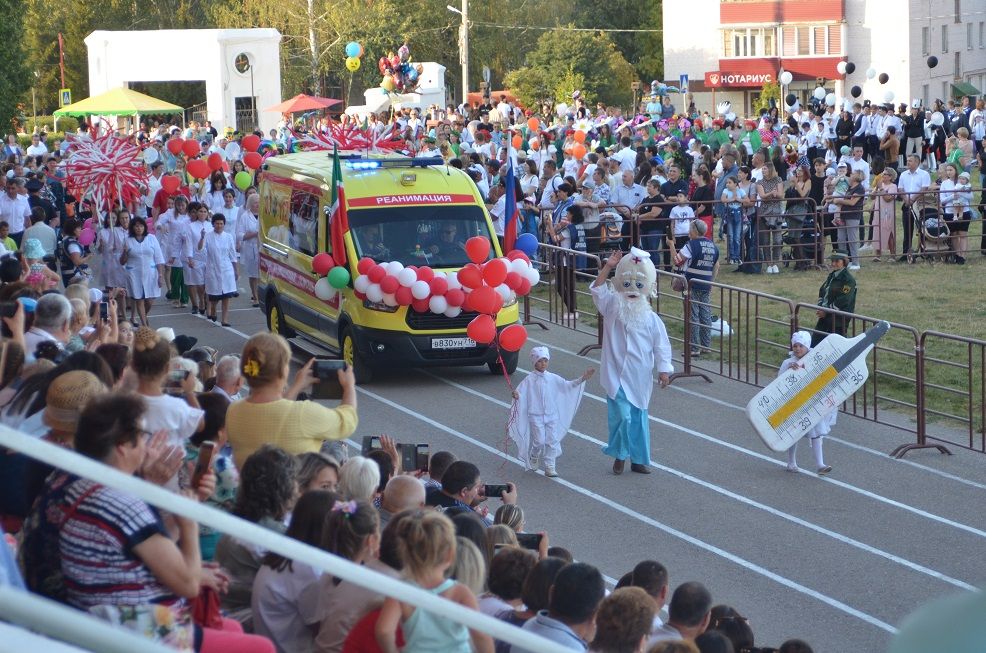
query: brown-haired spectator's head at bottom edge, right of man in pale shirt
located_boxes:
[589,587,654,653]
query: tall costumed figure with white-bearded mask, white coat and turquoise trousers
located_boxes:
[590,247,674,474]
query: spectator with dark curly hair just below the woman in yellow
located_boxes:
[216,445,298,626]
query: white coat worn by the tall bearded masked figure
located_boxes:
[590,283,674,410]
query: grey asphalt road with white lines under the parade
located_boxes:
[151,297,986,652]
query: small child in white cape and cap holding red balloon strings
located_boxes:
[508,347,596,477]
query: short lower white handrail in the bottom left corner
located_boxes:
[0,584,175,653]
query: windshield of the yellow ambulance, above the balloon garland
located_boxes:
[349,206,493,268]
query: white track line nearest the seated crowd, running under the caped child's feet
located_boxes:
[358,388,897,634]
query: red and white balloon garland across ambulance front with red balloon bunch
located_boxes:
[353,236,541,351]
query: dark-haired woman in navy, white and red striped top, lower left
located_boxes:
[26,395,274,653]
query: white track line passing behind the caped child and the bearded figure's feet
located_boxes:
[425,370,979,592]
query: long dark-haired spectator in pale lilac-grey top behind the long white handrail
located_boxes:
[254,488,336,653]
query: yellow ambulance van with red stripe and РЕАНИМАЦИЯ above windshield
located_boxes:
[259,151,518,382]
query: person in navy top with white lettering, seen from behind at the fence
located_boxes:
[668,220,719,357]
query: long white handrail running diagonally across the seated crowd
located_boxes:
[0,425,570,653]
